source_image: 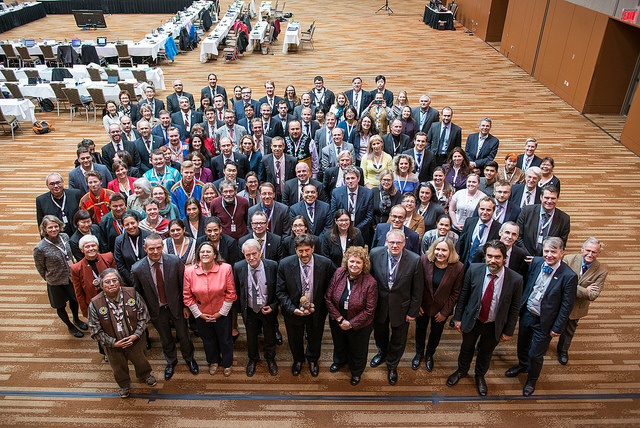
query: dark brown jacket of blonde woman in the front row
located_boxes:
[420,254,464,317]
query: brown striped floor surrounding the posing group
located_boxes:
[0,0,640,428]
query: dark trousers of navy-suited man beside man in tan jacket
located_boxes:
[518,310,551,382]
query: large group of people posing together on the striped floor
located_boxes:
[33,73,607,398]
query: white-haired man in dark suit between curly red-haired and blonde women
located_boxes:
[370,229,424,385]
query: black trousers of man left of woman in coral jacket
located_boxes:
[151,305,194,365]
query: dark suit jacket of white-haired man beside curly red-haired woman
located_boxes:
[370,247,424,327]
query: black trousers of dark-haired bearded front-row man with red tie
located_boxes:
[458,320,500,376]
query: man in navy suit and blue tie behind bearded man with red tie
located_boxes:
[458,196,501,268]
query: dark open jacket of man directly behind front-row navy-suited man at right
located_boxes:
[516,204,571,256]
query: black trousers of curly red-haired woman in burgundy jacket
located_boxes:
[329,320,373,376]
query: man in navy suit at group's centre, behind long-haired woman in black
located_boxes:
[331,165,373,242]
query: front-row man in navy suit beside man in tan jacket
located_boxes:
[505,237,578,397]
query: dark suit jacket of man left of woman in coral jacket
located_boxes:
[131,254,185,321]
